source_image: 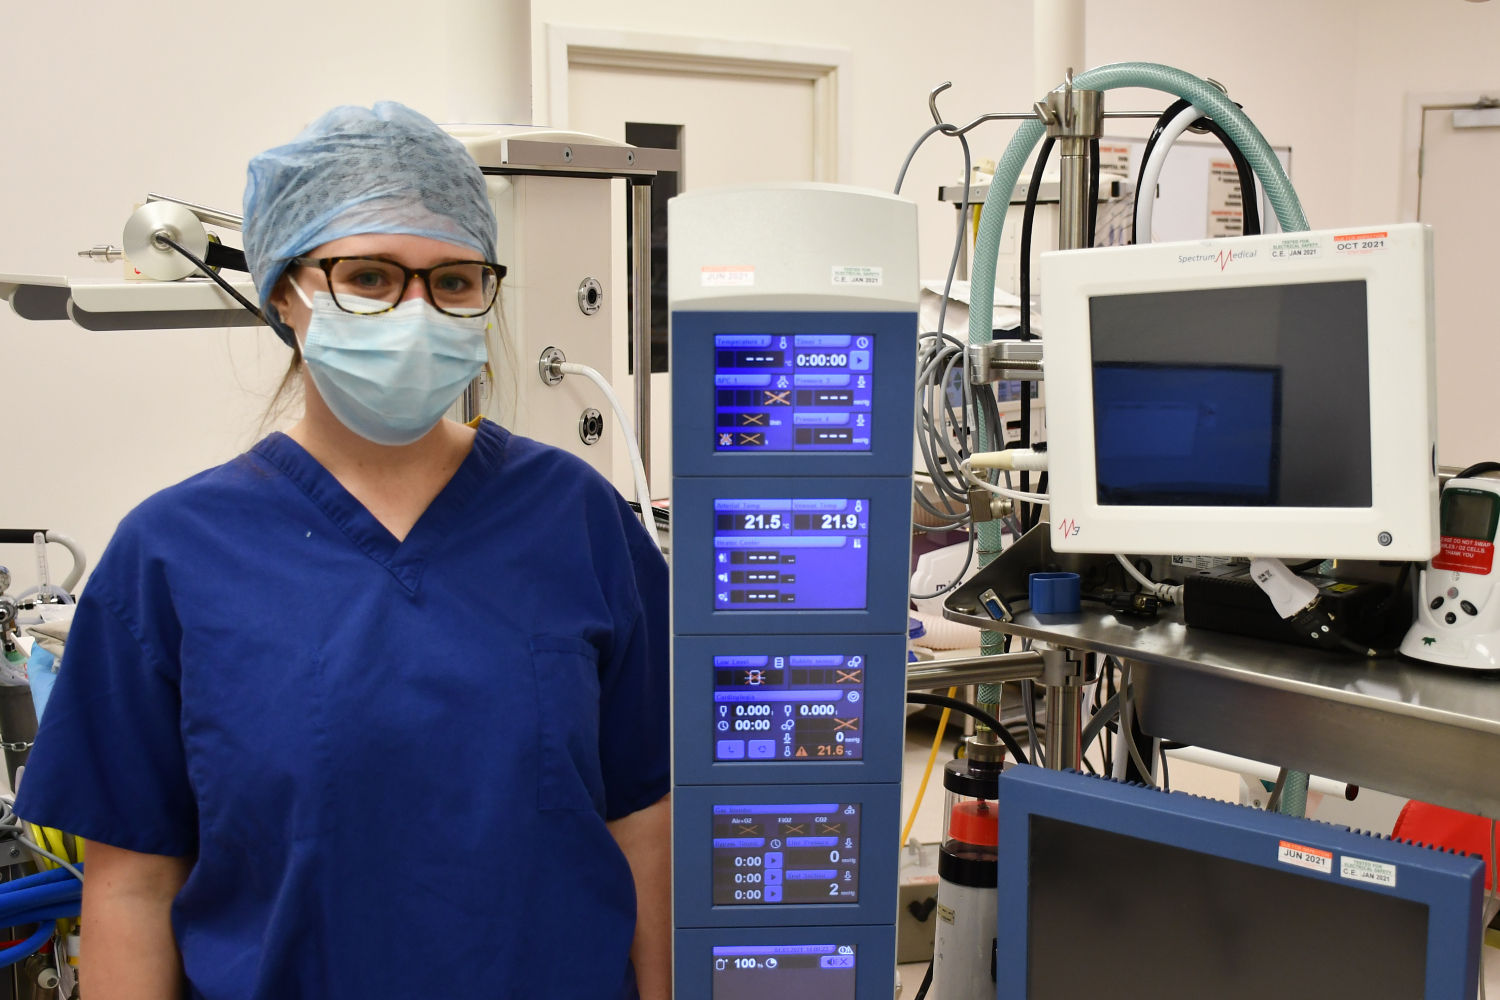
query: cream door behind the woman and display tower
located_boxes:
[567,64,836,498]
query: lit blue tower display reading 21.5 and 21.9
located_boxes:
[714,499,870,612]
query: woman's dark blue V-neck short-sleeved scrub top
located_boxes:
[17,423,671,1000]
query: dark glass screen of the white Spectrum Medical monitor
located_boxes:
[1089,280,1373,507]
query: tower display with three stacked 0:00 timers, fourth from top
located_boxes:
[714,802,860,906]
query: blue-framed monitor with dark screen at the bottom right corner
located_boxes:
[996,766,1485,1000]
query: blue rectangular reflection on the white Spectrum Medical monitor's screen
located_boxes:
[1094,363,1281,507]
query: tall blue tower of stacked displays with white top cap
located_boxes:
[668,184,918,1000]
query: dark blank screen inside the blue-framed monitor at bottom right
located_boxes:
[1026,814,1428,1000]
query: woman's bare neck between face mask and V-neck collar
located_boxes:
[287,375,474,541]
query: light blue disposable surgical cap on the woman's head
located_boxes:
[245,100,495,339]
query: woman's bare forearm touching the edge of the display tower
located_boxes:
[606,796,672,1000]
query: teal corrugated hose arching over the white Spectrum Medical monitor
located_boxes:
[969,63,1308,816]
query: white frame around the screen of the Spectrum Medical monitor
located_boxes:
[1041,222,1439,561]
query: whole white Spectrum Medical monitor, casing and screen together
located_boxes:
[1041,223,1437,561]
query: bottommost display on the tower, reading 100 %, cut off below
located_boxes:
[713,945,857,1000]
